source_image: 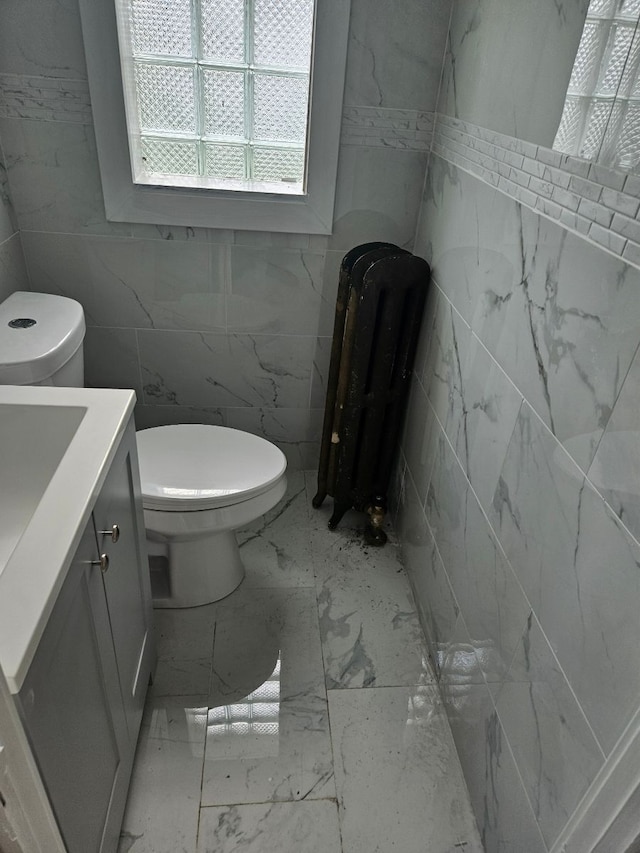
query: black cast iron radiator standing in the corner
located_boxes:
[313,243,430,545]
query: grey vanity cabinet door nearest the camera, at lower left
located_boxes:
[18,522,132,853]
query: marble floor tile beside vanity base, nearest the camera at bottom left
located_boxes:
[118,696,207,853]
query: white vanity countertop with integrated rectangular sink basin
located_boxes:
[0,385,135,692]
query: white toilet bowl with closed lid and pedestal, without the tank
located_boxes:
[137,424,287,607]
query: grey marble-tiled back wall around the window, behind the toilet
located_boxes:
[0,0,451,468]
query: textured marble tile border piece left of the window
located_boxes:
[0,74,92,124]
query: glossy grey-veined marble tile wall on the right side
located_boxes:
[396,0,640,853]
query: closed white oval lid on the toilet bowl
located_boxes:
[136,424,287,510]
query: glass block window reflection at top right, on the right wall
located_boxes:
[553,0,640,170]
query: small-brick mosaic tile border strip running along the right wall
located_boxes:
[431,115,640,267]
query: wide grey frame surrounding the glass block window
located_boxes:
[80,0,350,234]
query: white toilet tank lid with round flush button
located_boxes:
[0,290,85,385]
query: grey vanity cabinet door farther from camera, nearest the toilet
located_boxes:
[93,421,153,744]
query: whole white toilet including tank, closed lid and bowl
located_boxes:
[0,291,287,607]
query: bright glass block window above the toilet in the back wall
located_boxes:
[116,0,315,194]
